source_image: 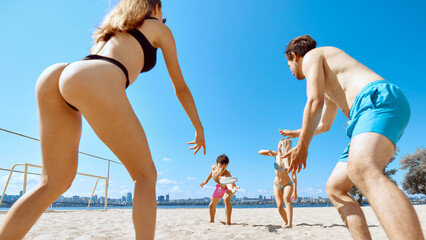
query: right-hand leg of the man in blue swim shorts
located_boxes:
[347,132,424,240]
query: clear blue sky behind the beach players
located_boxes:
[0,0,426,199]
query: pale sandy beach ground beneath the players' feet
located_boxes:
[0,205,426,240]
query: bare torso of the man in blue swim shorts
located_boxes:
[303,47,383,117]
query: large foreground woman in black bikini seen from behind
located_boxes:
[0,0,205,239]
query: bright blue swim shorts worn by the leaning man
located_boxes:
[339,80,411,162]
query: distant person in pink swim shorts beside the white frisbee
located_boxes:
[200,154,238,225]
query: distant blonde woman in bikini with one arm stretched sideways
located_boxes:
[259,139,297,227]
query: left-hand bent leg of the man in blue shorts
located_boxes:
[326,162,371,239]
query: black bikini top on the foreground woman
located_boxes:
[128,17,158,73]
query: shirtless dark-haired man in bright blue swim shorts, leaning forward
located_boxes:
[279,35,424,239]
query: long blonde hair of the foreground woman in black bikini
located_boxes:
[92,0,161,44]
